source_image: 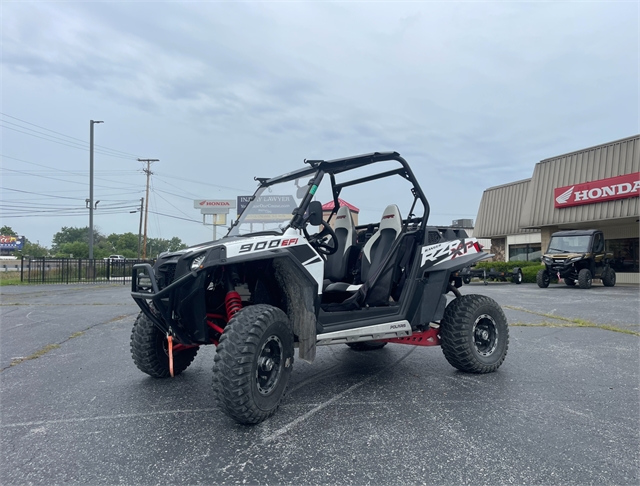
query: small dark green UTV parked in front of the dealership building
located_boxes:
[536,230,616,289]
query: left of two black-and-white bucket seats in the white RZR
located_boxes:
[324,206,357,287]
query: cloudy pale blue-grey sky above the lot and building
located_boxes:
[0,0,640,246]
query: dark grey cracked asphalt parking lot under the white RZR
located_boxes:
[0,283,640,485]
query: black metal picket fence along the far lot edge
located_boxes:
[20,257,154,285]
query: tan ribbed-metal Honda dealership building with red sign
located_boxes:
[474,136,640,283]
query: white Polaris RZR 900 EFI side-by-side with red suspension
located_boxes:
[131,152,509,424]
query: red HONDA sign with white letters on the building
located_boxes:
[553,172,640,208]
